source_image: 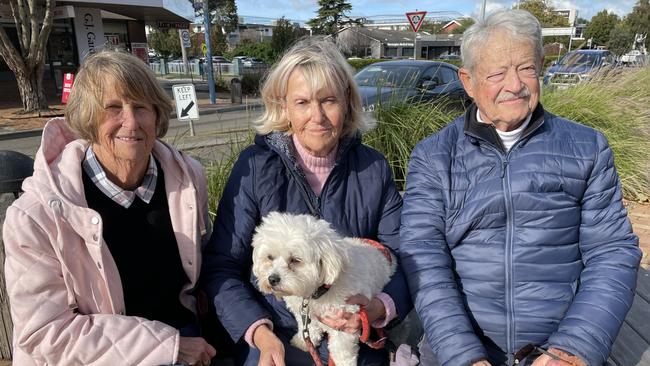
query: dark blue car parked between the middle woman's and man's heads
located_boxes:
[354,60,470,111]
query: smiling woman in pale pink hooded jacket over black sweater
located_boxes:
[4,52,215,366]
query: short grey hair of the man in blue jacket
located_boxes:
[460,9,544,71]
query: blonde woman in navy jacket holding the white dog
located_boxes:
[202,39,412,366]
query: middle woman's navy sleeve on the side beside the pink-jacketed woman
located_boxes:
[201,149,271,341]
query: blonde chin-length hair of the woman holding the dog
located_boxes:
[256,37,373,136]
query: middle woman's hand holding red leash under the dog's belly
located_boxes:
[318,294,386,334]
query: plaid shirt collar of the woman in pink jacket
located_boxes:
[82,145,158,208]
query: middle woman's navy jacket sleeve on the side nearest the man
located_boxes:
[377,160,413,320]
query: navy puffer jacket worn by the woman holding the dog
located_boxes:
[201,133,413,341]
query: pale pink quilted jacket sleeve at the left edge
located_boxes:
[3,206,179,365]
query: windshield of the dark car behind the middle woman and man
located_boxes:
[354,65,421,88]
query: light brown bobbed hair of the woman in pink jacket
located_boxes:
[65,51,172,142]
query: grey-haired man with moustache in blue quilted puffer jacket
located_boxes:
[400,10,641,366]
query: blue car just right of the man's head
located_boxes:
[544,50,616,88]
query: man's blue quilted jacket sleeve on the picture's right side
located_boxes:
[549,134,641,365]
